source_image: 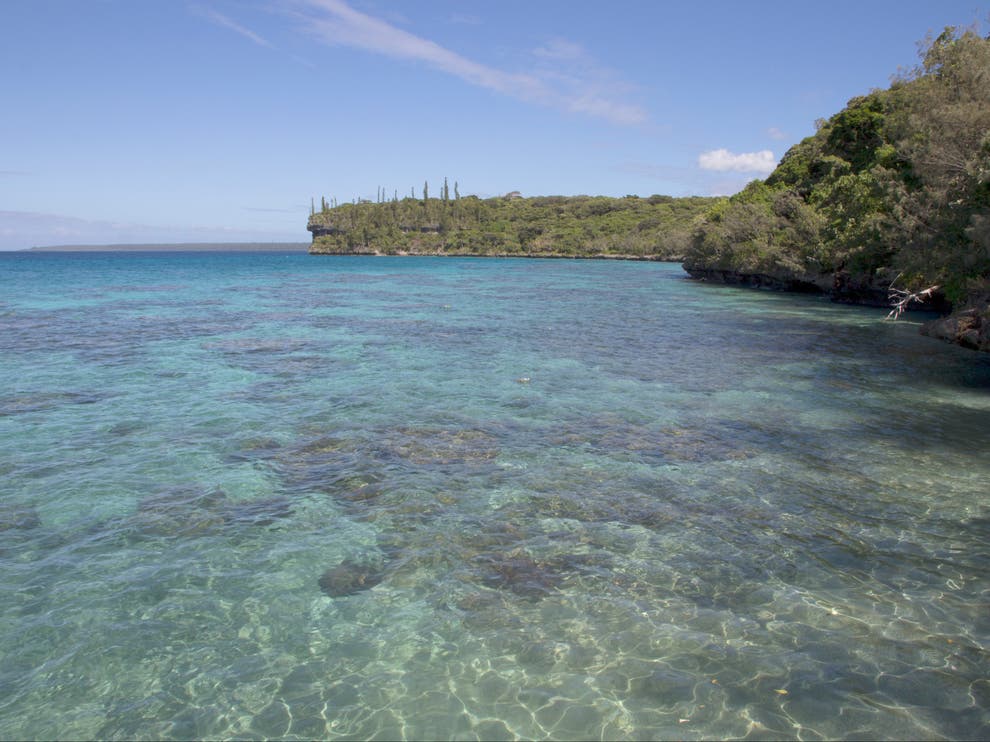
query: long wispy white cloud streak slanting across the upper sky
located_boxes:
[288,0,646,125]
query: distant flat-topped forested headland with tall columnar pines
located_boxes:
[307,192,717,260]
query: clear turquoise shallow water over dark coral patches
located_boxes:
[0,254,990,739]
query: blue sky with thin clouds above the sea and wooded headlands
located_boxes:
[0,0,990,249]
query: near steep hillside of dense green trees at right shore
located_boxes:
[684,28,990,350]
